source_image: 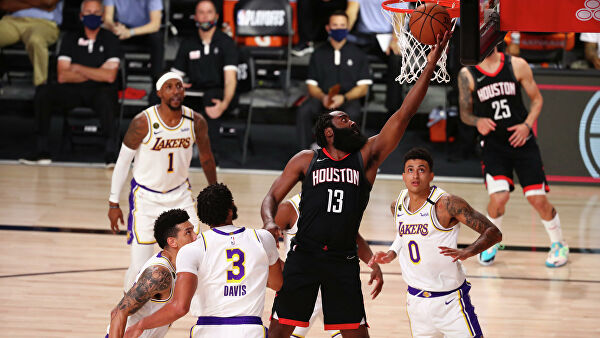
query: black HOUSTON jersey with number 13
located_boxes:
[295,149,371,251]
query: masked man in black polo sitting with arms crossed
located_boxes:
[20,0,120,165]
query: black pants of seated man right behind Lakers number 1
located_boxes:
[183,88,238,154]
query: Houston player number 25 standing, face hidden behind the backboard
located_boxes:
[458,49,569,268]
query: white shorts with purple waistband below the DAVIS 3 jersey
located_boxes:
[190,317,267,338]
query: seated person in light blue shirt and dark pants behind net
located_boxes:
[346,0,408,112]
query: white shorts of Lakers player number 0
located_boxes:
[406,282,483,338]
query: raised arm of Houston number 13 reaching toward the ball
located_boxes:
[363,31,451,174]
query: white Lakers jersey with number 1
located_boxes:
[133,106,196,192]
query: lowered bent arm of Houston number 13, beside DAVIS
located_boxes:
[260,150,314,241]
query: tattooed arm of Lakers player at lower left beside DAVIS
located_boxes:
[109,265,173,338]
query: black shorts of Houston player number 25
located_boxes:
[482,139,550,194]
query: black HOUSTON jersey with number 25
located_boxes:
[468,53,527,145]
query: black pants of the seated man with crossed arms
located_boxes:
[34,83,118,153]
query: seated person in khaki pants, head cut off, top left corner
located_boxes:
[0,0,63,86]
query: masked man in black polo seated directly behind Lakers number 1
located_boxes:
[171,0,238,157]
